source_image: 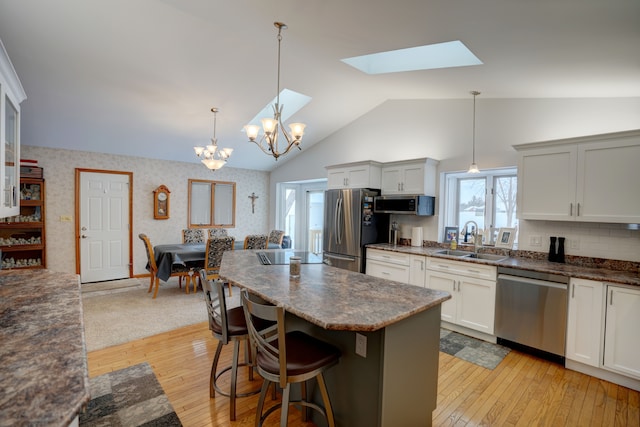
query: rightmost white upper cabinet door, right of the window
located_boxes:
[576,140,640,224]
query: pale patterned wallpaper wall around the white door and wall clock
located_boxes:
[21,146,270,275]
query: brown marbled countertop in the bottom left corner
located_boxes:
[0,269,90,426]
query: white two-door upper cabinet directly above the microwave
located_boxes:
[381,158,438,196]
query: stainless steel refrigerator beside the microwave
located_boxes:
[322,189,389,273]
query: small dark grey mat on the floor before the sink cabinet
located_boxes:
[440,329,511,369]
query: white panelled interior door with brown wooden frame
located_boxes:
[79,171,130,283]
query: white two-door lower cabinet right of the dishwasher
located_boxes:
[566,279,640,390]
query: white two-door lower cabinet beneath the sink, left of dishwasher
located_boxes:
[426,257,497,335]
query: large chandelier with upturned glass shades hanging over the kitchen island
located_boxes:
[244,22,306,160]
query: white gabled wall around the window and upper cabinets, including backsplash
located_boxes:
[270,95,640,261]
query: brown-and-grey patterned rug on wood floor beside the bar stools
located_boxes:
[80,362,182,427]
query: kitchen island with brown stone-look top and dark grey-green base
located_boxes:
[220,251,451,427]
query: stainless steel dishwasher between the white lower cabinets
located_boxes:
[495,267,569,359]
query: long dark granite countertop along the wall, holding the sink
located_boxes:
[367,243,640,286]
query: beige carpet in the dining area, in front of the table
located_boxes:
[82,278,210,351]
